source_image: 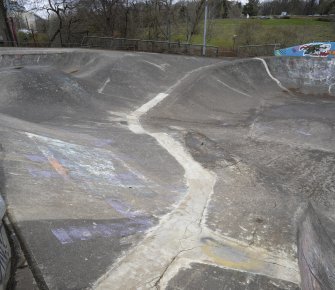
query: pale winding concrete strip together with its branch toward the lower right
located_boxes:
[95,60,299,289]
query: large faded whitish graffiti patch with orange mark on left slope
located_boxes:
[26,133,154,188]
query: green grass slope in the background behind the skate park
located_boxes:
[173,17,335,49]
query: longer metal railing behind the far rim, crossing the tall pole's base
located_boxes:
[81,36,219,57]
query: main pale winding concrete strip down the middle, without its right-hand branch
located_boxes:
[93,59,302,289]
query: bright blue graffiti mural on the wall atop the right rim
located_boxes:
[275,42,335,58]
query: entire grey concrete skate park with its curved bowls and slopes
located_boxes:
[0,49,335,289]
